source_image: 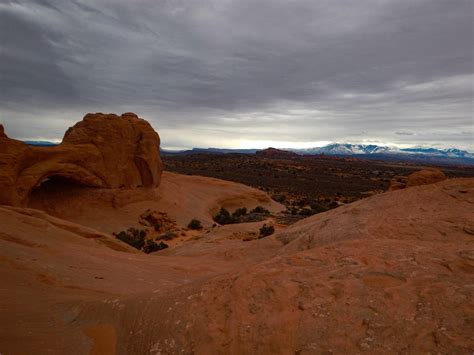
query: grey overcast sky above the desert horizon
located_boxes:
[0,0,474,151]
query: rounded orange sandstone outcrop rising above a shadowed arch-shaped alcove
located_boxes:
[0,113,163,206]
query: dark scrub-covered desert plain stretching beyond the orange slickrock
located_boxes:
[164,154,472,224]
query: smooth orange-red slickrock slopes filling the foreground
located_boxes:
[0,173,474,354]
